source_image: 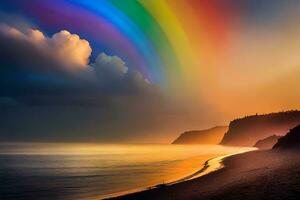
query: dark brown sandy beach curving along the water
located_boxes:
[110,150,300,200]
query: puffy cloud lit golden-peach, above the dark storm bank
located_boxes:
[0,24,92,71]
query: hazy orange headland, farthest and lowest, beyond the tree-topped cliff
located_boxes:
[172,126,228,144]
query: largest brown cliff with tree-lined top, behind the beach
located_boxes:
[220,111,300,146]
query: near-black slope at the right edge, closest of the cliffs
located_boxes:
[273,125,300,150]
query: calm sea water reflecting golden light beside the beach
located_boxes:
[0,143,252,200]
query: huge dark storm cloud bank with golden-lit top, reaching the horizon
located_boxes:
[0,24,173,142]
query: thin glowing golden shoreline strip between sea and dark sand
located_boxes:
[104,148,257,200]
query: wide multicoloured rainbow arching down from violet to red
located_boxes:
[12,0,233,85]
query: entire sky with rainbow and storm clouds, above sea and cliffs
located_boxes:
[0,0,300,143]
